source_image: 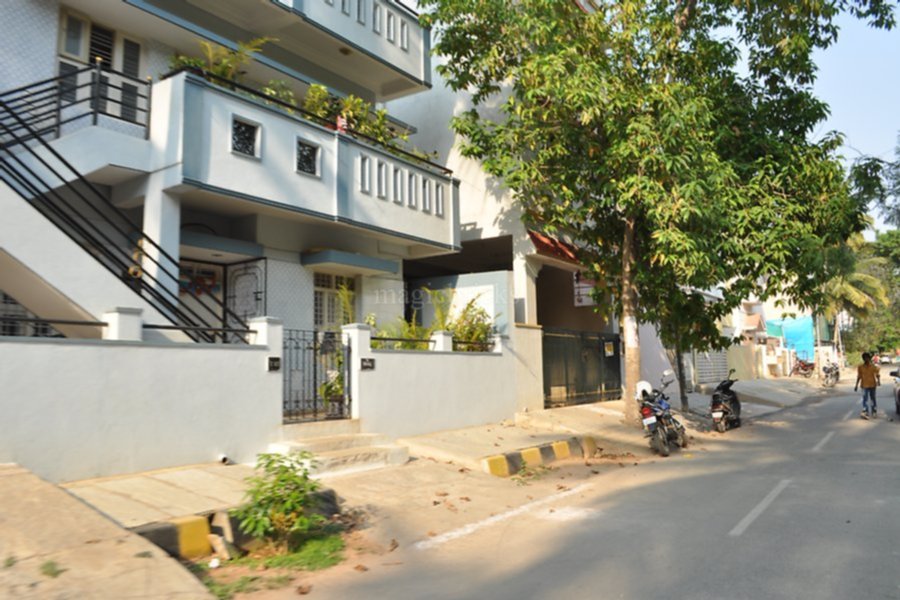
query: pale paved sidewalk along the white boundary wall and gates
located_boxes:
[28,379,829,576]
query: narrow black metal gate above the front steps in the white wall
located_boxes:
[283,329,350,423]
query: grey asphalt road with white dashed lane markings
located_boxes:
[273,385,900,599]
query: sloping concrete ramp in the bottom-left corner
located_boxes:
[0,465,211,600]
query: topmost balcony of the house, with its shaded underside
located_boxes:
[122,0,431,102]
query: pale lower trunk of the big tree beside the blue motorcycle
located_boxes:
[622,216,641,427]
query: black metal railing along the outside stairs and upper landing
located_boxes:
[0,66,249,343]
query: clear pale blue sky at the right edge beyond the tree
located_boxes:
[814,15,900,239]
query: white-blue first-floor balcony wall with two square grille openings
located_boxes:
[160,72,459,255]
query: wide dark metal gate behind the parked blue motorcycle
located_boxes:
[542,329,622,408]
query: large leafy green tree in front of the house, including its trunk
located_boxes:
[420,0,893,424]
